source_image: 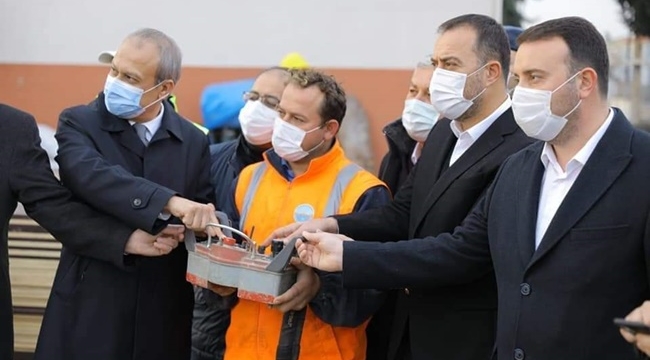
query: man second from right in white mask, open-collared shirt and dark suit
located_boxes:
[264,15,532,360]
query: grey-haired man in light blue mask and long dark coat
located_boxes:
[35,29,217,360]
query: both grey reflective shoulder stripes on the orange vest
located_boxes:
[239,162,363,231]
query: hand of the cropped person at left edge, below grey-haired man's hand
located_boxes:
[124,225,185,256]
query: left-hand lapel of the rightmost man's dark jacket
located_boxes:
[514,143,544,267]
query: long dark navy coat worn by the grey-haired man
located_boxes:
[35,94,214,360]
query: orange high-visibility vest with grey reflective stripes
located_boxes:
[225,143,385,360]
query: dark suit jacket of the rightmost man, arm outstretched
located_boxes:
[343,110,650,360]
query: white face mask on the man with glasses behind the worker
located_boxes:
[239,100,278,145]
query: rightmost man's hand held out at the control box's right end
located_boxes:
[296,232,352,272]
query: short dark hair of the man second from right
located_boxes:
[438,14,510,82]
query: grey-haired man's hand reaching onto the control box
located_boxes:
[165,196,224,239]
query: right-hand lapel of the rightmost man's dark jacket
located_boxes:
[528,110,633,269]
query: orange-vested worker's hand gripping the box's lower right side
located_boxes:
[271,258,320,313]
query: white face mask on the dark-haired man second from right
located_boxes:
[429,64,487,120]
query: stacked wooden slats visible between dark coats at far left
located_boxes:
[9,210,61,353]
